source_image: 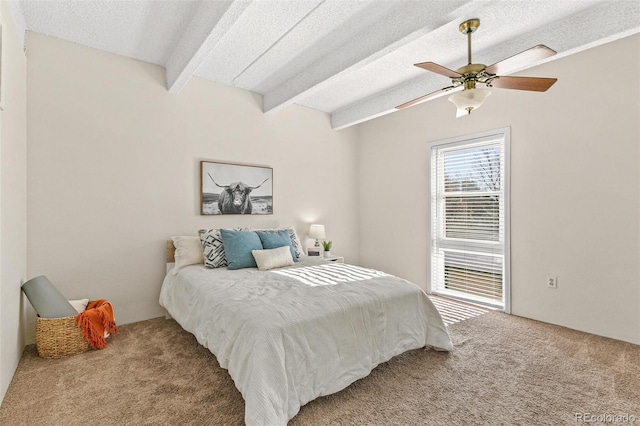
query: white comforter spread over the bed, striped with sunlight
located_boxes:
[160,259,452,425]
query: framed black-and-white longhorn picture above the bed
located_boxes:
[200,161,273,215]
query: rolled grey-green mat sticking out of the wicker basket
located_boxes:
[22,275,78,318]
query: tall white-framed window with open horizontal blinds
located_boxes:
[429,128,510,312]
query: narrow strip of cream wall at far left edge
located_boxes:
[0,1,27,401]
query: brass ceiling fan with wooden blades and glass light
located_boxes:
[396,19,558,117]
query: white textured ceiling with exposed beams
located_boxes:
[12,0,640,128]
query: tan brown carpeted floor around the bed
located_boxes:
[0,300,640,426]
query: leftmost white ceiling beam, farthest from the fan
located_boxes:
[165,0,251,93]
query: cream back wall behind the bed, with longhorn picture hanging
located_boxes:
[27,33,358,340]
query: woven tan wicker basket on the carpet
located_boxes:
[36,317,90,359]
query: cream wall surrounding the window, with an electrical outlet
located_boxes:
[358,35,640,343]
